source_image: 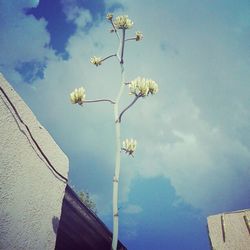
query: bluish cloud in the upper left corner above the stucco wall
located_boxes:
[0,0,54,82]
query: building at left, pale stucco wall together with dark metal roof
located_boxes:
[0,74,126,250]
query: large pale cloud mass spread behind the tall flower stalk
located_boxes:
[1,0,250,216]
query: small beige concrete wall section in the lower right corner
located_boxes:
[208,209,250,250]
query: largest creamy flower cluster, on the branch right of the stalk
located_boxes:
[129,77,159,97]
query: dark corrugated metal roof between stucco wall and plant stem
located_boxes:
[55,185,127,250]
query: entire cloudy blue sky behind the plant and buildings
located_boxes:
[0,0,250,250]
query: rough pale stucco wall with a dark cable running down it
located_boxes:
[0,74,68,250]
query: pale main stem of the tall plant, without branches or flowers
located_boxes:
[112,27,125,250]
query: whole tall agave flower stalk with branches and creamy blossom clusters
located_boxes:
[70,13,158,250]
